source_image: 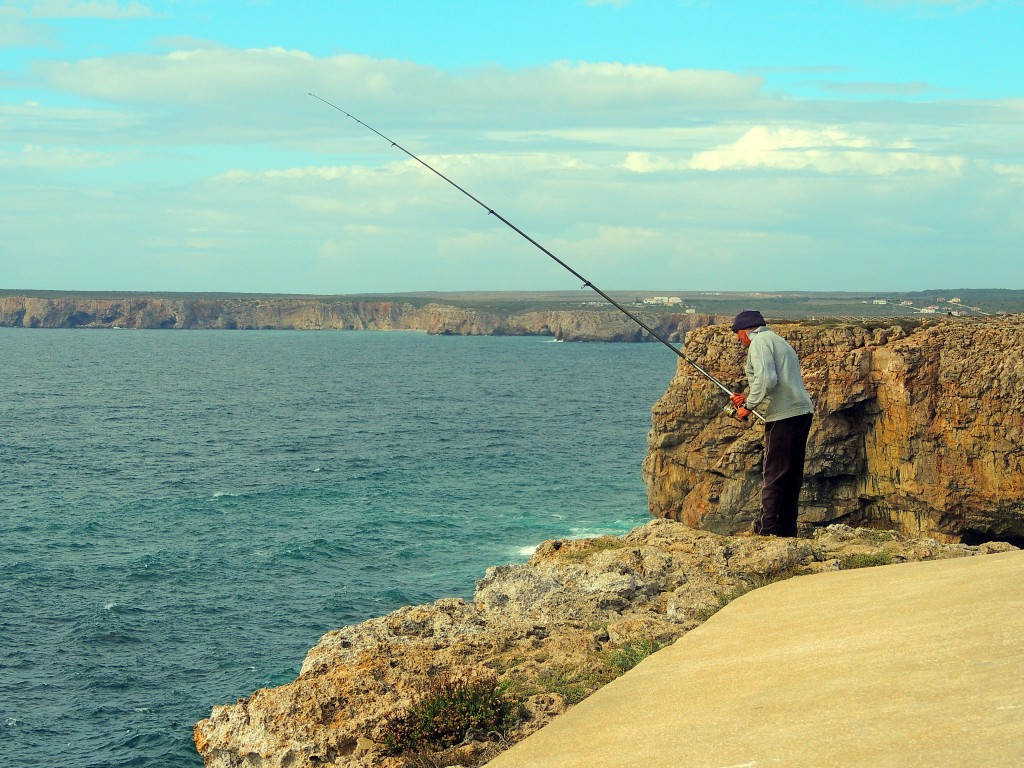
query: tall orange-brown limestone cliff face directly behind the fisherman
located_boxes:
[643,315,1024,541]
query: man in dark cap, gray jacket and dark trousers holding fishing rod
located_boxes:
[732,309,814,537]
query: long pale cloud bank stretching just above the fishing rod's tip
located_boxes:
[38,45,763,112]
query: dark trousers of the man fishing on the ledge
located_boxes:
[754,414,811,536]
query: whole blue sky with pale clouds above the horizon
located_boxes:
[0,0,1024,295]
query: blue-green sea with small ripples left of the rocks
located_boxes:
[0,329,677,768]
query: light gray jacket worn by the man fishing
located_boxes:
[745,326,814,421]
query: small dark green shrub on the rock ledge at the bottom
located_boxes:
[383,675,520,755]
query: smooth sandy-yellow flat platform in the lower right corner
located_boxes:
[487,552,1024,768]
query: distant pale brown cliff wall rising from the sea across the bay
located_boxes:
[0,296,716,342]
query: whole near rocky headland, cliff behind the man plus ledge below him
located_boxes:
[195,315,1024,768]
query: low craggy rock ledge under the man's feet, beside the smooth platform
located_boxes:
[195,520,1014,768]
